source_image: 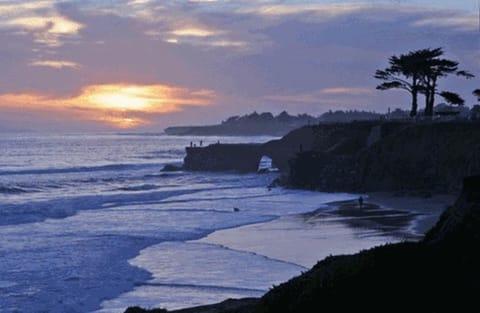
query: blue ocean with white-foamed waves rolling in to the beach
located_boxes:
[0,133,382,313]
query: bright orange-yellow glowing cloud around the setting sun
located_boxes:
[0,84,215,128]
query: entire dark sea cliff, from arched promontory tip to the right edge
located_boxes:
[184,121,480,194]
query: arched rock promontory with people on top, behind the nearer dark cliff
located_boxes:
[184,122,378,173]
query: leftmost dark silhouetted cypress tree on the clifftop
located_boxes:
[374,52,422,116]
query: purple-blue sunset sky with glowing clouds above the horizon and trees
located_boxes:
[0,0,480,131]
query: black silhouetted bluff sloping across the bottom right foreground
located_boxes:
[125,176,480,313]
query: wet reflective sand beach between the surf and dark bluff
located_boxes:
[196,193,455,269]
